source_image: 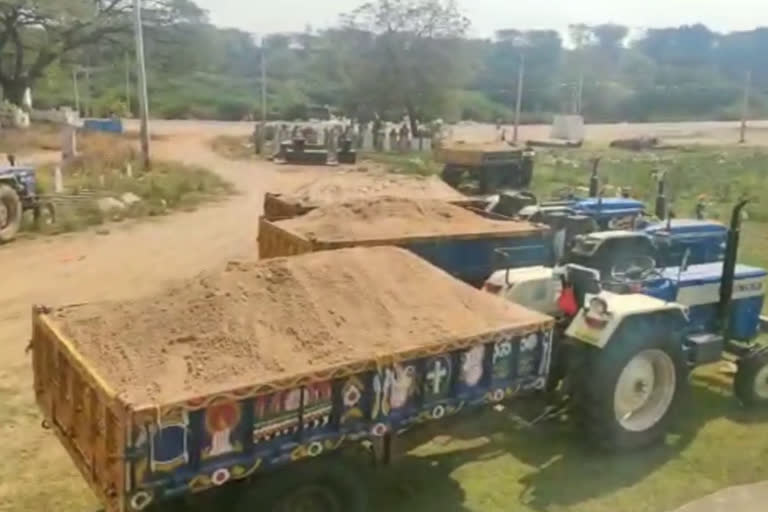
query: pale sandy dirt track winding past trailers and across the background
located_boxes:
[0,118,768,512]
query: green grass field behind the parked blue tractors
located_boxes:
[366,146,768,278]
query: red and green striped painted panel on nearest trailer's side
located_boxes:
[253,382,332,443]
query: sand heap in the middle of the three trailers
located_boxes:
[276,197,541,241]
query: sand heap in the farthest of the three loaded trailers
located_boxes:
[281,170,463,207]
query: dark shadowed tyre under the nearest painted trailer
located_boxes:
[234,457,368,512]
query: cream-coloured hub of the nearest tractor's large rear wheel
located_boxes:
[614,349,676,432]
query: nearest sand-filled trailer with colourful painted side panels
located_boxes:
[31,247,552,512]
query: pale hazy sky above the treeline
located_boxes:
[195,0,768,36]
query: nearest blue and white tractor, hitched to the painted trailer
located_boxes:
[484,202,768,449]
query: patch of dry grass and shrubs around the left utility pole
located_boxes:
[5,125,234,237]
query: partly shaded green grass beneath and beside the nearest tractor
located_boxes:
[364,368,768,512]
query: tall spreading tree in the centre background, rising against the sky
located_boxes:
[344,0,469,132]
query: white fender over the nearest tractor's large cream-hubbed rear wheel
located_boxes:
[566,292,688,349]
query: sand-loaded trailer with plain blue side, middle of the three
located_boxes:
[259,196,554,286]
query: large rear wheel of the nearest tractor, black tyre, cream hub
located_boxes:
[569,322,688,450]
